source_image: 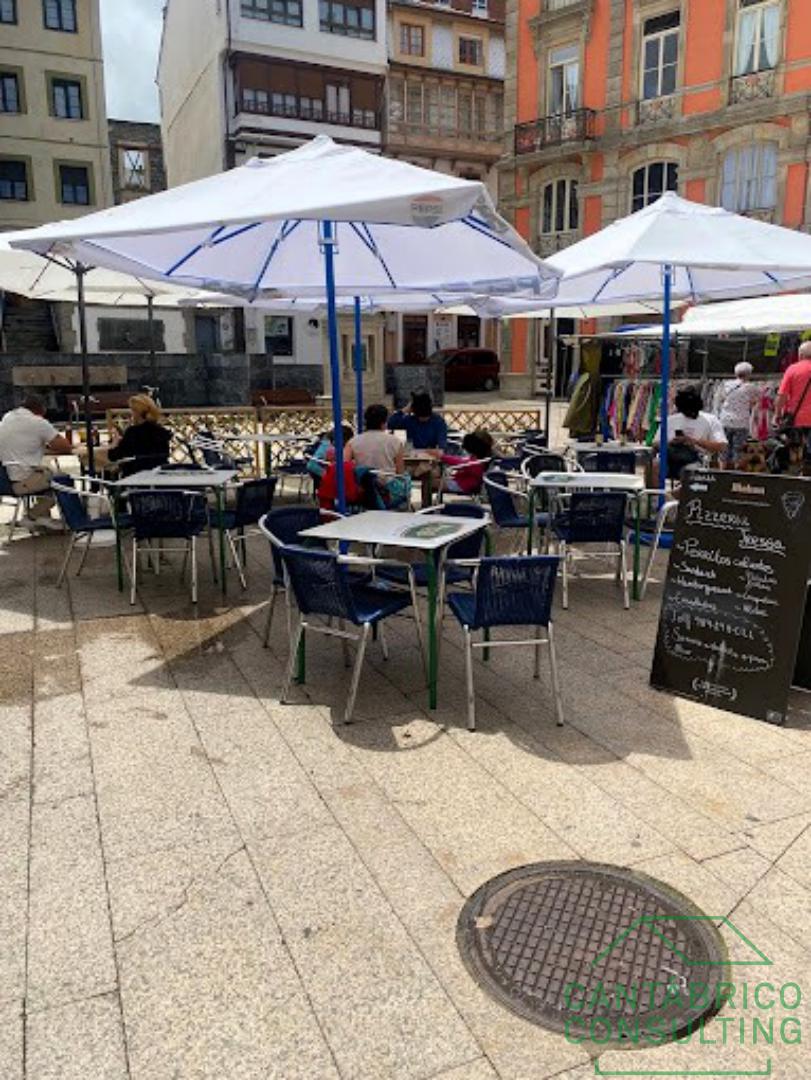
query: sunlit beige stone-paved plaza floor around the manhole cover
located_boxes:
[0,518,811,1080]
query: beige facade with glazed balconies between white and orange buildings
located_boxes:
[383,0,504,180]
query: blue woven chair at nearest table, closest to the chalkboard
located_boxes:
[448,555,564,731]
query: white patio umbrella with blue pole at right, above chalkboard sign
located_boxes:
[498,192,811,484]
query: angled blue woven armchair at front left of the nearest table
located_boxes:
[281,548,416,724]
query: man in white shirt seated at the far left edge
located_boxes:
[0,394,72,529]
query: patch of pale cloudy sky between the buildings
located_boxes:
[102,0,164,122]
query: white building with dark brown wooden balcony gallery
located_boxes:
[158,0,387,186]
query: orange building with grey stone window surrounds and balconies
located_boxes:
[499,0,811,382]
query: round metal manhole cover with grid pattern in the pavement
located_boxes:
[457,862,728,1045]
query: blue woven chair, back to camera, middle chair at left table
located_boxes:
[127,488,214,604]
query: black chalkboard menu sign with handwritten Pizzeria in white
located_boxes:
[650,469,811,724]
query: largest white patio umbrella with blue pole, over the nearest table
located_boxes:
[12,136,556,505]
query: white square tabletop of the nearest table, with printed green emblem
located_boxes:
[300,510,489,551]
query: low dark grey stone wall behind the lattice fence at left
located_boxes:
[0,352,323,418]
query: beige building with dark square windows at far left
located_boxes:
[0,0,112,230]
